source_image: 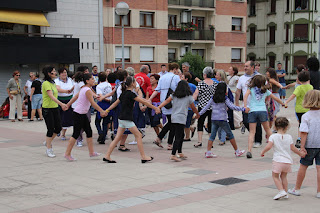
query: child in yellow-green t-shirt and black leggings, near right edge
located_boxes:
[285,71,313,148]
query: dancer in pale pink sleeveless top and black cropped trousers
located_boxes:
[64,73,107,161]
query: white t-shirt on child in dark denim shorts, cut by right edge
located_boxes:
[299,110,320,148]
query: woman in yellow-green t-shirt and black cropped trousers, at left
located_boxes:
[42,66,68,158]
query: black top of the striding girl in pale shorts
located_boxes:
[119,90,137,121]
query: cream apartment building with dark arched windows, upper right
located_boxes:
[247,0,320,79]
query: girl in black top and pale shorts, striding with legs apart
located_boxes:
[103,76,160,163]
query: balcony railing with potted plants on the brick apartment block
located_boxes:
[168,30,214,41]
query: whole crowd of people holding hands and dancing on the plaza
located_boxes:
[2,57,320,200]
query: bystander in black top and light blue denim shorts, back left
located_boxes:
[28,74,43,121]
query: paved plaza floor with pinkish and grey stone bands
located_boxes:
[0,100,320,213]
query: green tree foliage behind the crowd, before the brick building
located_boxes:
[178,51,206,79]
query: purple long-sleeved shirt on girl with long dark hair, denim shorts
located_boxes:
[199,97,245,121]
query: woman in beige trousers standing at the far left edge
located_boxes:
[7,70,23,122]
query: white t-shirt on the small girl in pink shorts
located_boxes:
[269,133,293,164]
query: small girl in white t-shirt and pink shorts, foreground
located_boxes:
[261,117,305,200]
